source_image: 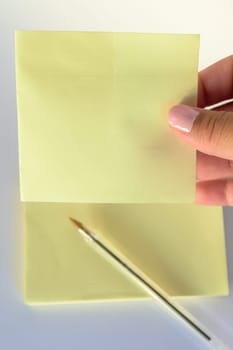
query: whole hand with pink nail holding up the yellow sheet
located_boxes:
[169,55,233,205]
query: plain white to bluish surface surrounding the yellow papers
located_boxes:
[0,0,233,350]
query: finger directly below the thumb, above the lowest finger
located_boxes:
[197,152,233,181]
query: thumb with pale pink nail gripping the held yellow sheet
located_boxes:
[168,105,233,160]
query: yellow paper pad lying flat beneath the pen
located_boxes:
[24,203,228,303]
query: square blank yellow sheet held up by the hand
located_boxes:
[16,31,199,203]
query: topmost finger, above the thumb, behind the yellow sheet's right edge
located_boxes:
[198,55,233,107]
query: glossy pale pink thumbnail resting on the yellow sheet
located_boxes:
[168,105,200,132]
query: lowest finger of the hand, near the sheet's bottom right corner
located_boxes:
[196,179,233,206]
